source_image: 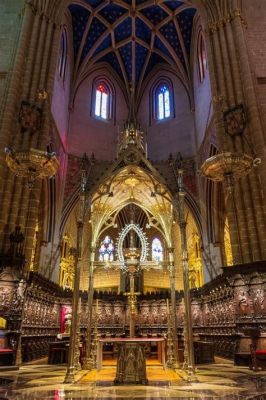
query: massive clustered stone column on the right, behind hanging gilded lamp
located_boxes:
[201,0,266,264]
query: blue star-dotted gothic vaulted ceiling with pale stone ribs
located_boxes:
[69,0,196,103]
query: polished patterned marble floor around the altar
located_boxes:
[0,362,266,400]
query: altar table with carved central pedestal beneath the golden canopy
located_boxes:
[97,337,165,385]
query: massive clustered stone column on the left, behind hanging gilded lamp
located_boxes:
[0,1,62,268]
